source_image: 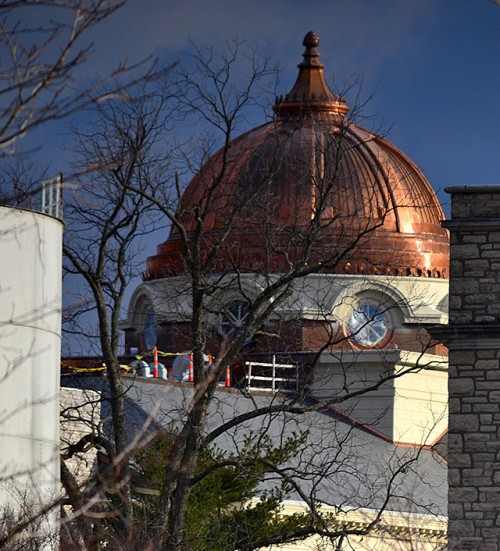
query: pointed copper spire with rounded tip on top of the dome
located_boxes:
[273,31,349,118]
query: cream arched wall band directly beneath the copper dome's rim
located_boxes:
[123,274,448,327]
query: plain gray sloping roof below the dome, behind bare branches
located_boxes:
[63,377,447,515]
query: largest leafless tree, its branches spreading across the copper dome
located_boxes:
[59,36,450,551]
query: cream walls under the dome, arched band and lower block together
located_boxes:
[124,274,448,445]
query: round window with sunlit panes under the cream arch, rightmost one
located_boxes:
[348,302,390,347]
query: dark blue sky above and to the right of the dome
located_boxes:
[77,0,500,216]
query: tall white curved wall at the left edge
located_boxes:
[0,207,63,549]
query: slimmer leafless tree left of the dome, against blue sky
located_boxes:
[64,80,172,540]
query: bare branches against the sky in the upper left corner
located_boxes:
[0,0,137,155]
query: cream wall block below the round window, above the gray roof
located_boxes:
[310,350,448,446]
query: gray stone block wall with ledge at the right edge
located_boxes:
[440,186,500,551]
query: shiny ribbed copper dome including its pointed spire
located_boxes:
[145,32,449,279]
